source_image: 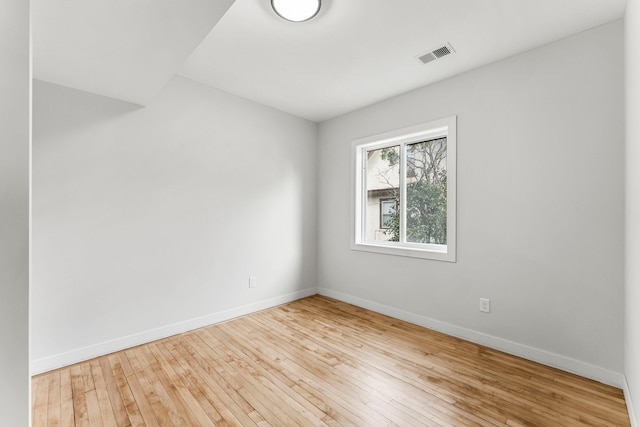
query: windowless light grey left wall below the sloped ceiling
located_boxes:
[31,77,317,371]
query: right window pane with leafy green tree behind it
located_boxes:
[406,138,447,245]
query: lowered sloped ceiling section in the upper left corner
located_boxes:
[31,0,233,105]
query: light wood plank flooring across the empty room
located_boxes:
[32,296,629,427]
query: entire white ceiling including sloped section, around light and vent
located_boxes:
[32,0,626,121]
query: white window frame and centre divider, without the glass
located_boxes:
[351,116,457,262]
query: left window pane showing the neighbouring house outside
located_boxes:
[365,145,400,242]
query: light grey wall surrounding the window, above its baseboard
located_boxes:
[318,21,624,385]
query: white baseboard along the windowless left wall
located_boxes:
[30,288,317,375]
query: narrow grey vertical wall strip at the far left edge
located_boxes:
[0,0,30,426]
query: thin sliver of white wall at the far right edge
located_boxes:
[625,0,640,426]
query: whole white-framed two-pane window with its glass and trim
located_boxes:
[351,116,456,262]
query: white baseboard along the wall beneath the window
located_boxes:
[318,288,626,395]
